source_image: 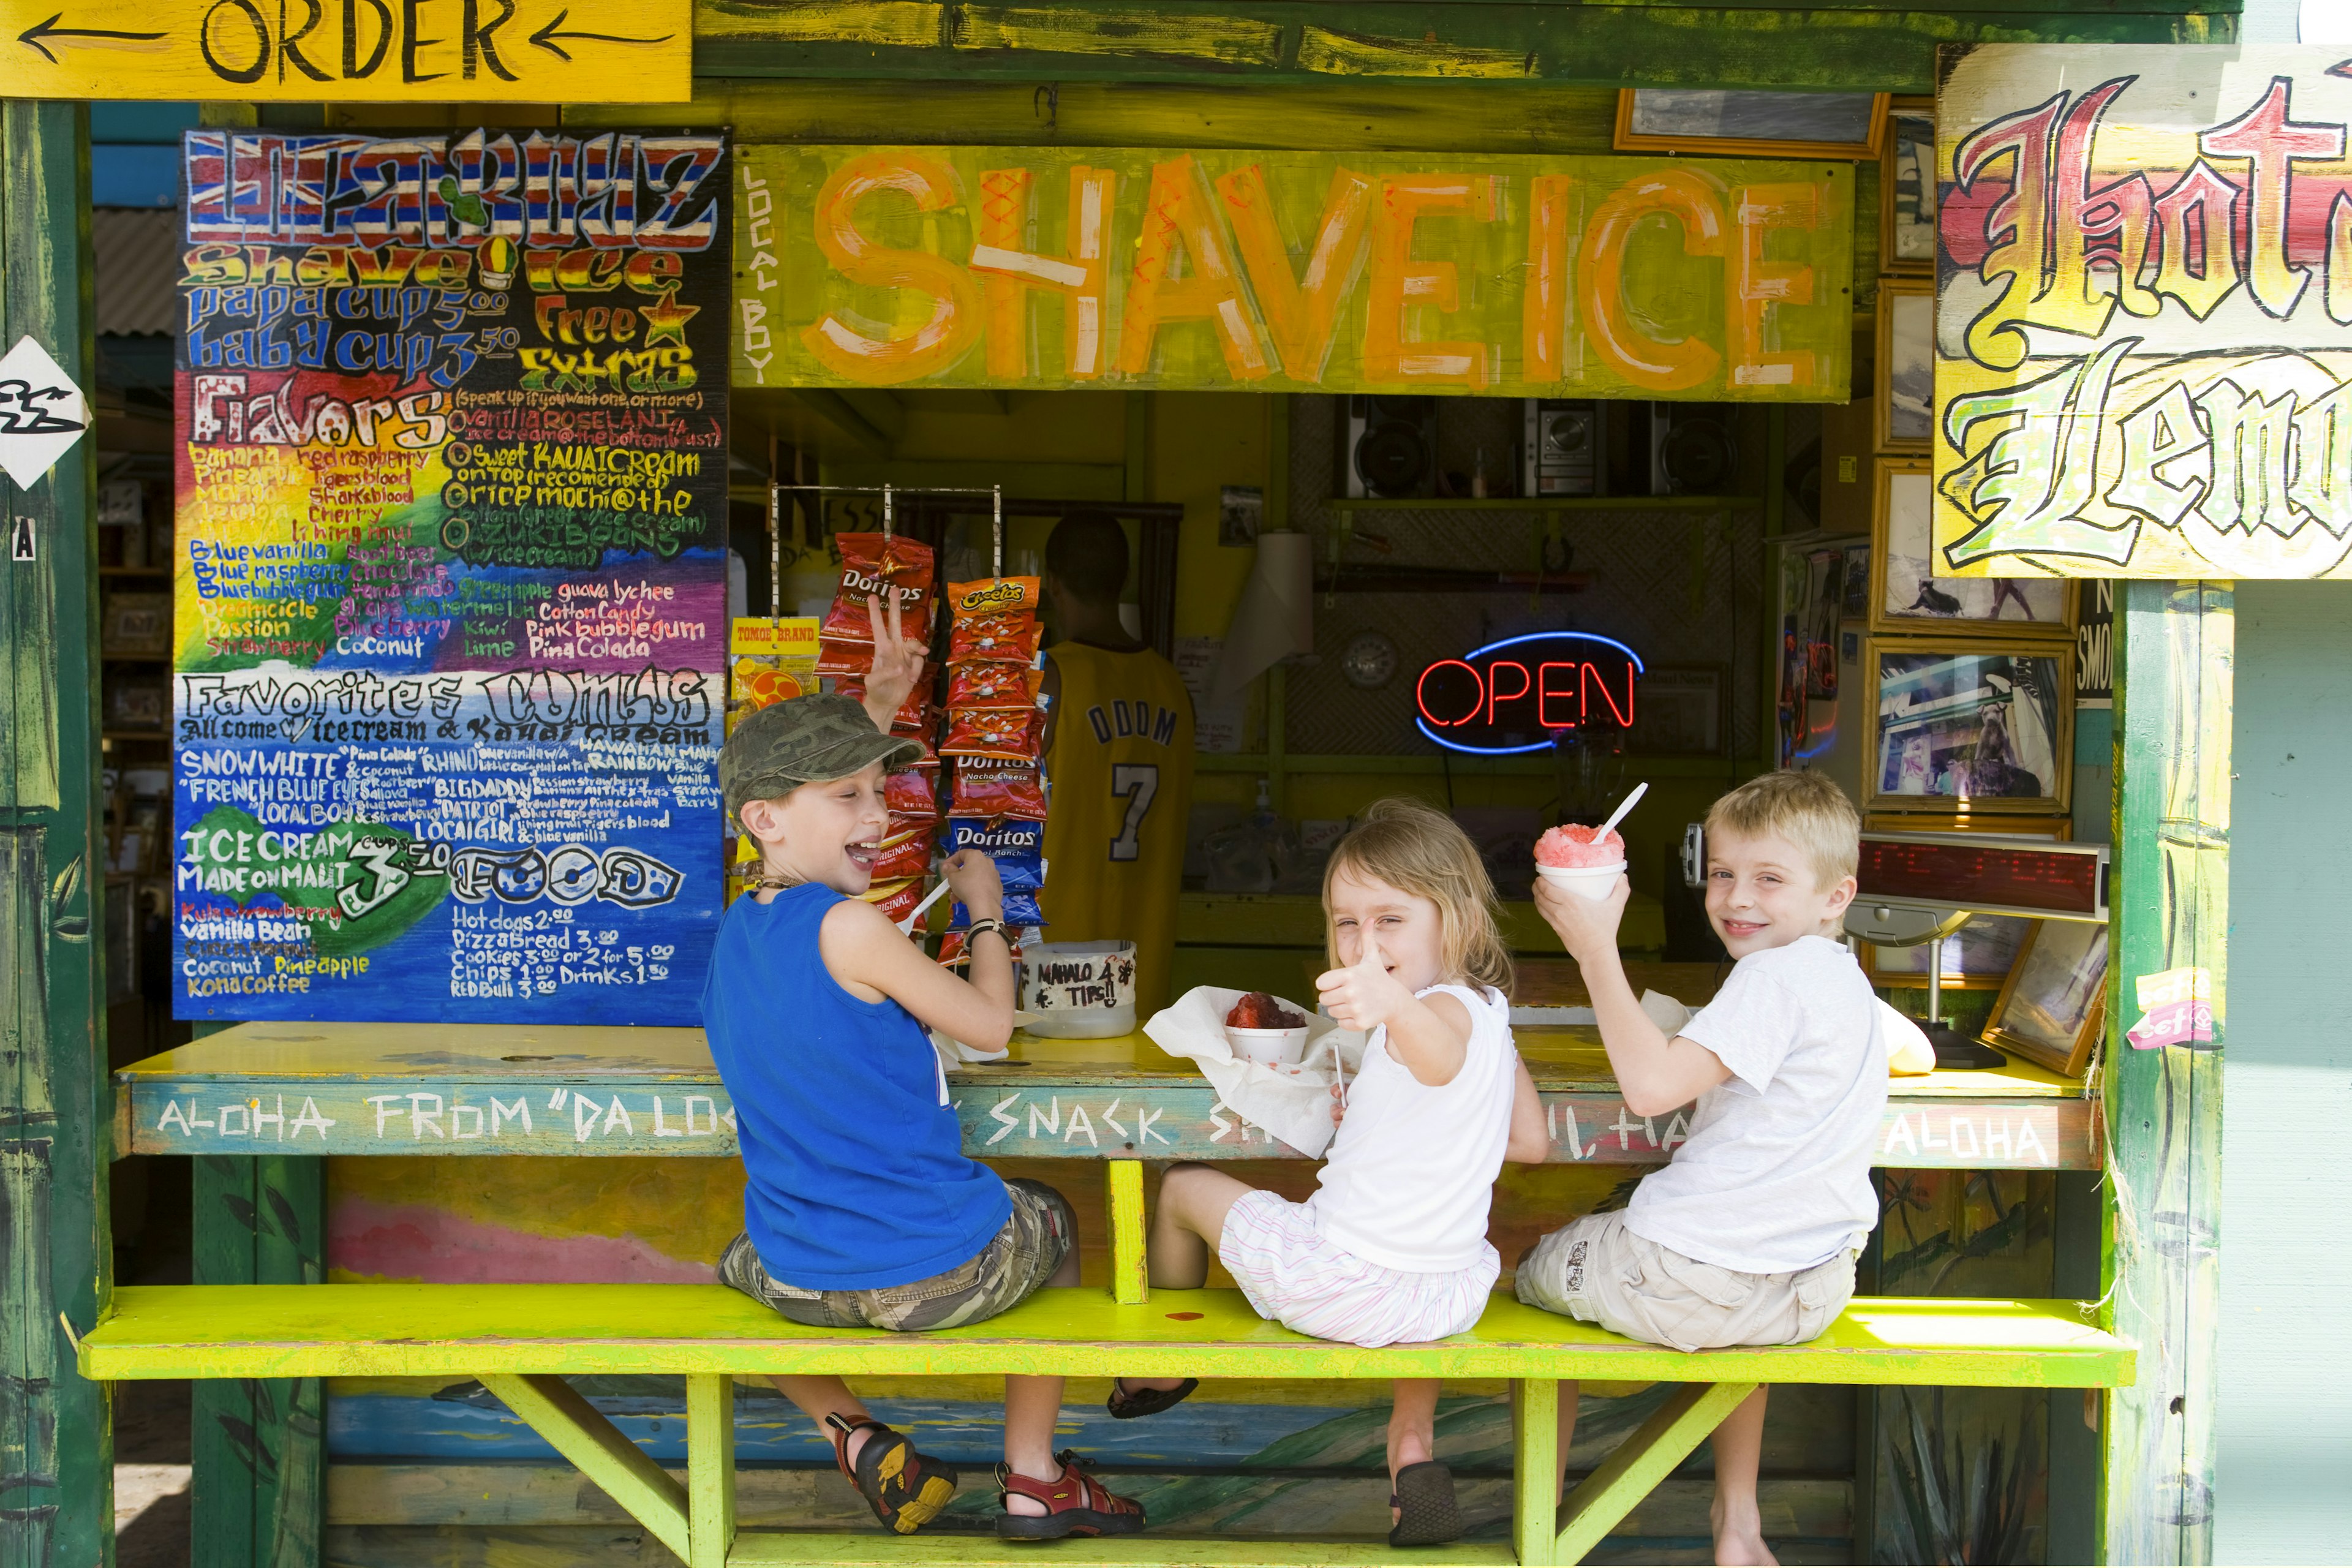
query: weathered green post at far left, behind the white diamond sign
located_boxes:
[0,99,113,1568]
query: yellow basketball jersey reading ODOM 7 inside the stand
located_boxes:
[1044,642,1193,1016]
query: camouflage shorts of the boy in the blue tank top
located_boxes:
[720,1175,1077,1333]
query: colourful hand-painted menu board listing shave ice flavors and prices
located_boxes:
[172,129,731,1023]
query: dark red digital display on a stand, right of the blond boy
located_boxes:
[1846,832,2108,1067]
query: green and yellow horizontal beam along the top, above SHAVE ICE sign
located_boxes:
[694,0,2237,94]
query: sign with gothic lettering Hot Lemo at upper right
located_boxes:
[1933,45,2352,578]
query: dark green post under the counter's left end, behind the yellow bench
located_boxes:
[190,1154,327,1568]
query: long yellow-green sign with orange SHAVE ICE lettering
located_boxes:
[734,146,1853,402]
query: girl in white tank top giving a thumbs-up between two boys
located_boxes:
[1150,799,1550,1547]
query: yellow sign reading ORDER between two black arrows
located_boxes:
[0,0,694,104]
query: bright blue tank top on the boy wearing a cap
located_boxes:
[703,881,1011,1291]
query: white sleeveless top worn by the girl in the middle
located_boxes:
[1308,985,1520,1274]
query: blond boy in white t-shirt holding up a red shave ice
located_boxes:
[1517,774,1936,1563]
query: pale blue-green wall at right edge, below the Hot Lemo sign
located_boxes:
[2213,583,2352,1563]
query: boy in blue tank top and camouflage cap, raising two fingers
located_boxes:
[703,635,1190,1540]
